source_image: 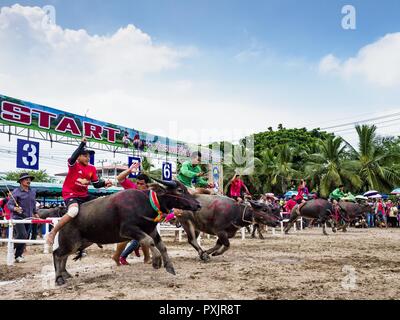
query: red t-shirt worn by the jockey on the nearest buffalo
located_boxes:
[62,161,99,200]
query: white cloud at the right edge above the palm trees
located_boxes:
[319,32,400,87]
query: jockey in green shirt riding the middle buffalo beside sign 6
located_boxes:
[178,152,210,189]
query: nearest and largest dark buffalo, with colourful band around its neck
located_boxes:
[53,180,201,285]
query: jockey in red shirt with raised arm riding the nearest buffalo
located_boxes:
[47,138,113,244]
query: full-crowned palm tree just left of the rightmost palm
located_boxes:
[305,137,361,197]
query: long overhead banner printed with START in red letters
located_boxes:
[0,95,220,163]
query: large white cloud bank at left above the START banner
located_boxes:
[0,5,296,142]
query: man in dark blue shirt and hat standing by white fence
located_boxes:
[7,173,39,263]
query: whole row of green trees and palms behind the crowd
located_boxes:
[221,125,400,197]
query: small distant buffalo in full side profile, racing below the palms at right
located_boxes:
[285,199,336,235]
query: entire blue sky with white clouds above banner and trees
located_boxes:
[0,0,400,175]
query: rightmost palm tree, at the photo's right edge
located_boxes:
[353,125,400,192]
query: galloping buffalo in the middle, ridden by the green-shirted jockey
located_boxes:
[178,195,280,261]
